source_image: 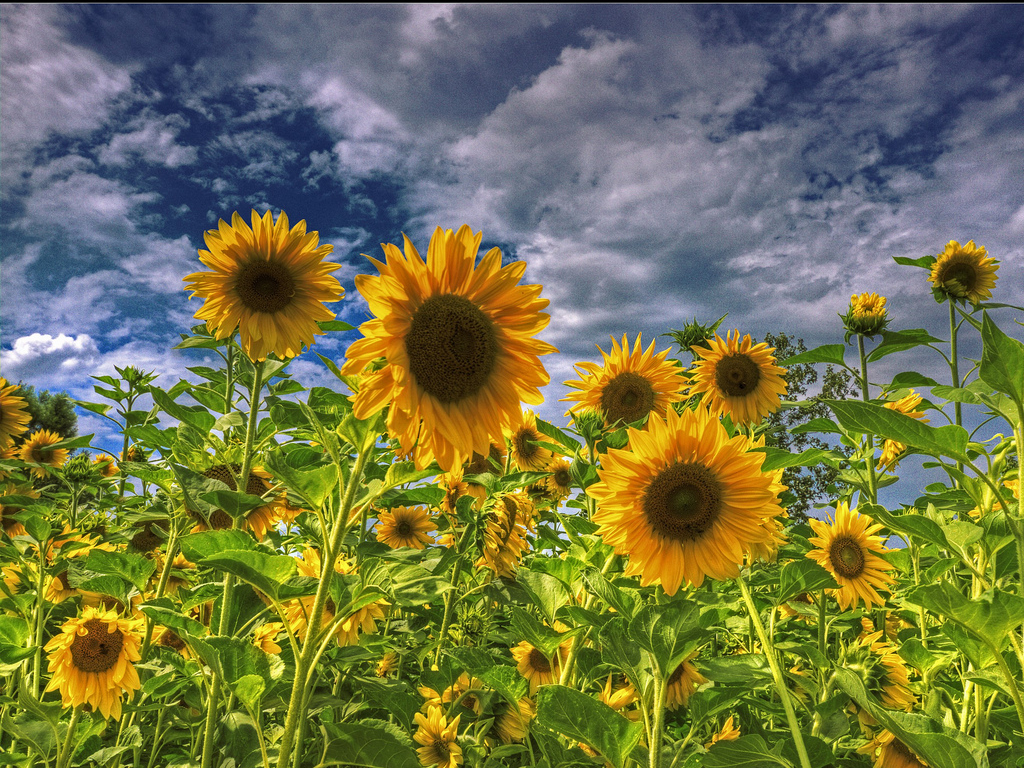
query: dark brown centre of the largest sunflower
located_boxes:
[406,294,498,403]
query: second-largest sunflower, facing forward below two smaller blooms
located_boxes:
[587,408,782,595]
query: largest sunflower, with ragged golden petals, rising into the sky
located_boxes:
[342,225,557,472]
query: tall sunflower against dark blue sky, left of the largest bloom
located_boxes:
[184,211,345,360]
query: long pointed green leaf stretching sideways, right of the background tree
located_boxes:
[822,400,969,462]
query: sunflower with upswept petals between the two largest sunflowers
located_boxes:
[562,334,686,427]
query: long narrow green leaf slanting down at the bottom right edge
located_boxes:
[836,669,988,768]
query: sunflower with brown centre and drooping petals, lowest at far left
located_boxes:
[45,607,144,720]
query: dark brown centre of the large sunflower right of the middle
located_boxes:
[643,464,722,541]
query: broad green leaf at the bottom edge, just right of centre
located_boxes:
[537,685,643,768]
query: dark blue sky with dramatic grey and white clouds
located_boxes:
[0,4,1024,512]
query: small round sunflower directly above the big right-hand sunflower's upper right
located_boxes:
[689,331,785,424]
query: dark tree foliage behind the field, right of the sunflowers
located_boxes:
[764,332,859,522]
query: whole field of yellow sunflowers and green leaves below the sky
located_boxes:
[0,212,1024,768]
